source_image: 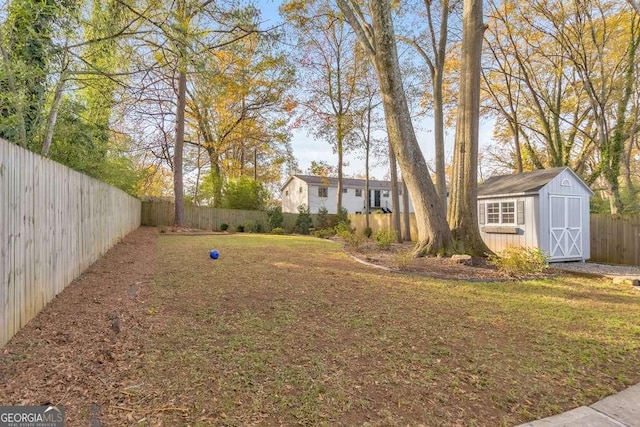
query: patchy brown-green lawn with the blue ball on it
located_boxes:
[136,234,640,426]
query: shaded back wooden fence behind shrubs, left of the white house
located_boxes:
[142,202,298,233]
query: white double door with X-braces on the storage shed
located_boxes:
[549,196,582,259]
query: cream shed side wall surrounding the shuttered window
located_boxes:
[479,196,539,252]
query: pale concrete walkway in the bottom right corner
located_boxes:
[520,384,640,427]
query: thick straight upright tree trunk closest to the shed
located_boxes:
[449,0,490,256]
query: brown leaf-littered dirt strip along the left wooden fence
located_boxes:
[0,228,157,426]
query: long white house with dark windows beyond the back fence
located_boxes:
[280,175,413,214]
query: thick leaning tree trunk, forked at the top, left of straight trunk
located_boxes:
[337,0,454,256]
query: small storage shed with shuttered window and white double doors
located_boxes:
[478,167,593,262]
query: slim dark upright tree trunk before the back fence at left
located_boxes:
[173,65,187,227]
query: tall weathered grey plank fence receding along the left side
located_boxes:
[0,139,140,346]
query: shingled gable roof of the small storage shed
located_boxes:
[478,166,591,197]
